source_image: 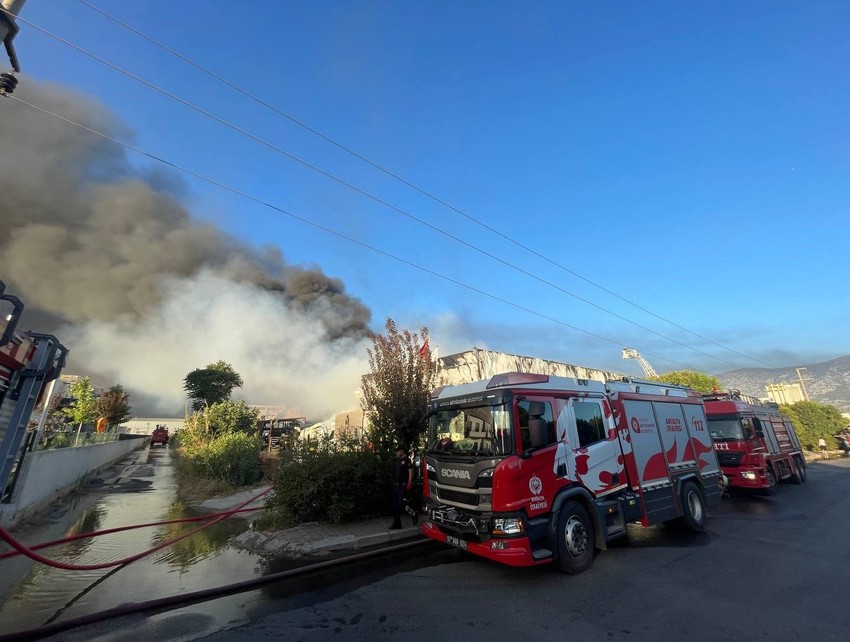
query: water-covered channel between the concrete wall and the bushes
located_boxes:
[0,449,268,634]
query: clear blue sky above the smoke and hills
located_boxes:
[8,0,850,374]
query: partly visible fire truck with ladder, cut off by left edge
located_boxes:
[0,281,68,497]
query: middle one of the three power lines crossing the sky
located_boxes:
[0,9,746,368]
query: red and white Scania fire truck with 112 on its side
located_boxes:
[421,372,723,574]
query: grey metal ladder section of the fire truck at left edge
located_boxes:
[0,332,68,501]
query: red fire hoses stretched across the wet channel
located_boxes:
[0,488,272,571]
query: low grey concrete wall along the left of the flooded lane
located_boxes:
[0,437,148,527]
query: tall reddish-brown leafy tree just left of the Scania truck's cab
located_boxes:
[361,317,433,453]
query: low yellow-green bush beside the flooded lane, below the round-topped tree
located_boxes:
[182,433,263,486]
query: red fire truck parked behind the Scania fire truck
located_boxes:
[703,390,806,494]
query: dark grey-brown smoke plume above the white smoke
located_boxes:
[0,79,370,340]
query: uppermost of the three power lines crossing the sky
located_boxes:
[69,0,773,367]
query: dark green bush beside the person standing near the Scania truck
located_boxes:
[262,439,392,527]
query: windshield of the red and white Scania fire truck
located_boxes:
[428,405,513,457]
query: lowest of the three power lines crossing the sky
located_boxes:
[6,89,700,369]
